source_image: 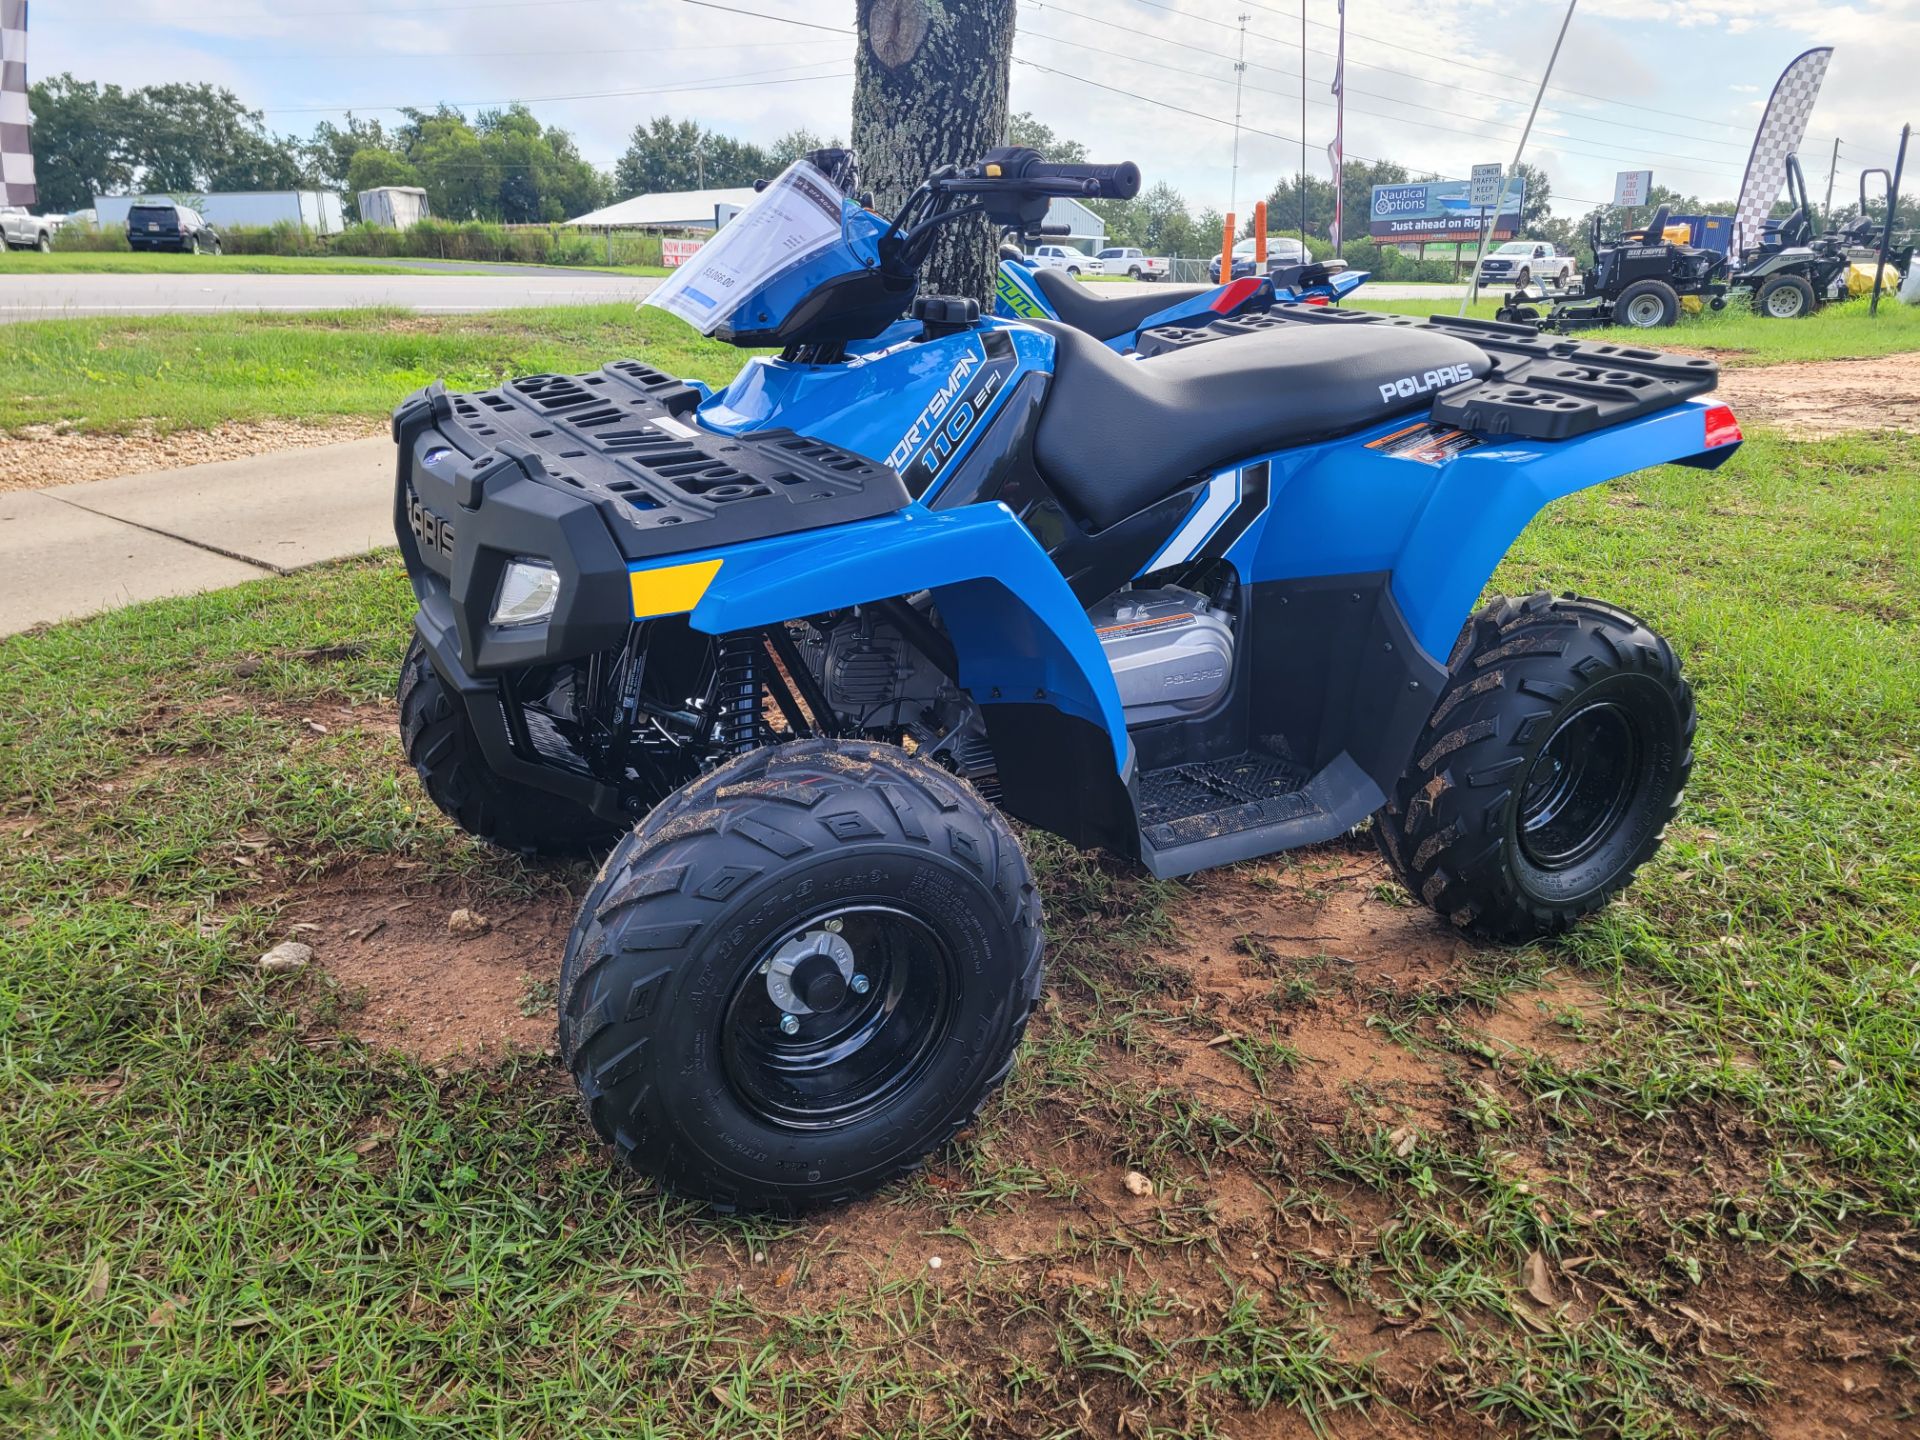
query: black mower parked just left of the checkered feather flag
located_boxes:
[1496,205,1728,332]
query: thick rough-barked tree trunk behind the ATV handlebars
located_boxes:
[852,0,1014,303]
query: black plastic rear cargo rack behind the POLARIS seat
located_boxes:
[1140,305,1720,440]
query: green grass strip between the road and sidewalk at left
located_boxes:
[0,305,743,432]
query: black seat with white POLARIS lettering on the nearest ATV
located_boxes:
[1033,318,1494,530]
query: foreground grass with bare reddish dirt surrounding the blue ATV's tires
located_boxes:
[0,422,1920,1440]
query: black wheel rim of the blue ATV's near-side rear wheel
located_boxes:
[1519,701,1644,872]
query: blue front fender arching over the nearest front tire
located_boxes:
[636,505,1131,778]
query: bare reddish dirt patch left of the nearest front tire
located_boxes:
[282,860,576,1068]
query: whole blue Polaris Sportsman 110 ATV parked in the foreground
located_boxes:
[394,148,1740,1212]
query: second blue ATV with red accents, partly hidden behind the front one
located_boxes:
[993,237,1367,355]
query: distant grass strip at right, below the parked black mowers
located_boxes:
[1348,288,1920,365]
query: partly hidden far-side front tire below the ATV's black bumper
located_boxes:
[399,636,622,854]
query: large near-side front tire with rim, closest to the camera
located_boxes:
[559,739,1041,1213]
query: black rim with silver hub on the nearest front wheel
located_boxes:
[720,906,958,1129]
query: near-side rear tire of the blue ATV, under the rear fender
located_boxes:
[1373,593,1695,941]
